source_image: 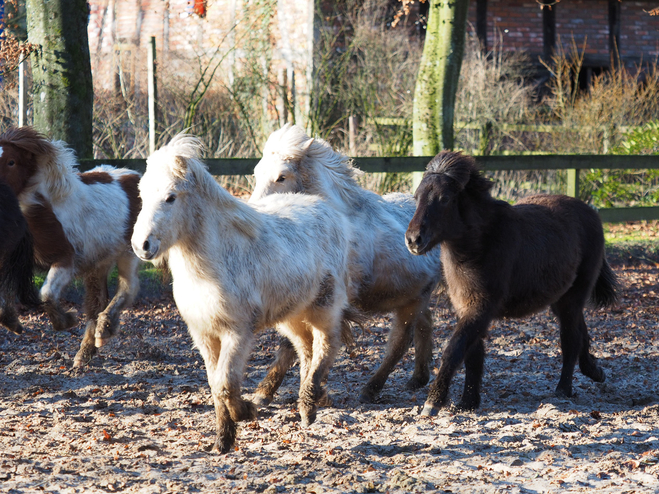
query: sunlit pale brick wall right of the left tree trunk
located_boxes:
[88,0,313,123]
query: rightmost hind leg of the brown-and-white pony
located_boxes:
[94,252,140,348]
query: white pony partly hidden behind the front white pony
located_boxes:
[250,125,441,403]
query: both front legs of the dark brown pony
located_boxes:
[421,314,492,416]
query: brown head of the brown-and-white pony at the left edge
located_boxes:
[0,127,56,195]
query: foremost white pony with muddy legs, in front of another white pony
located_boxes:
[132,134,349,452]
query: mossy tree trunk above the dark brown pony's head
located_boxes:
[413,0,469,156]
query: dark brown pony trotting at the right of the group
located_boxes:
[405,152,616,415]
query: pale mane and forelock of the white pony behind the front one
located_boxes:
[263,124,363,207]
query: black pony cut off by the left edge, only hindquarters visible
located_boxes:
[0,181,39,334]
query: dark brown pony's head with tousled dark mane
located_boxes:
[405,151,492,255]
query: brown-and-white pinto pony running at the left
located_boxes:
[0,127,141,366]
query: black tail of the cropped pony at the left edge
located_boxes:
[0,227,41,307]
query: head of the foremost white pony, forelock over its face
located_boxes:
[131,134,205,261]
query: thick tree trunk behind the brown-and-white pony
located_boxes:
[27,0,94,158]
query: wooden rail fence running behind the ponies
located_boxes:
[80,154,659,223]
